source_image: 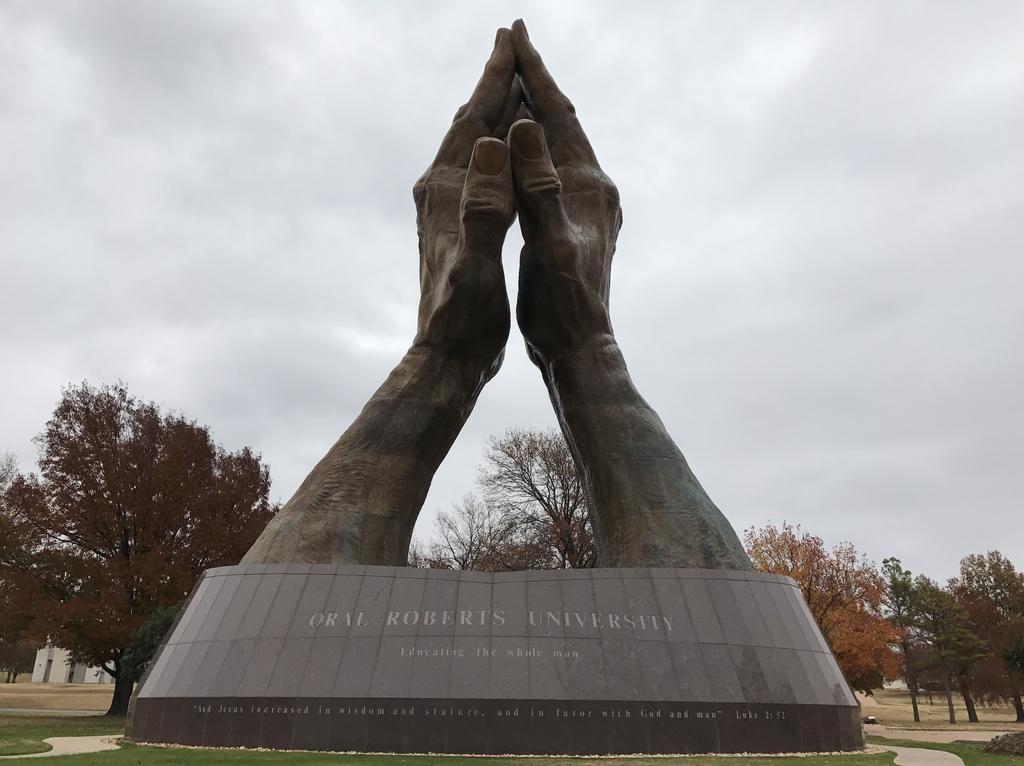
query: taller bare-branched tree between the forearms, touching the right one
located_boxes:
[478,429,596,569]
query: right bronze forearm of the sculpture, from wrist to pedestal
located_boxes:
[542,336,751,569]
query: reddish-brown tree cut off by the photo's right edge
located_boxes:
[949,551,1024,722]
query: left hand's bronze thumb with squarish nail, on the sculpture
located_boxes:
[460,136,515,260]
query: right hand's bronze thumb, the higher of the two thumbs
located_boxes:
[509,120,569,252]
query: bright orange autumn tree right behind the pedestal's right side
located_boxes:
[743,522,899,693]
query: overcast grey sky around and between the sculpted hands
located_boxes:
[0,0,1024,578]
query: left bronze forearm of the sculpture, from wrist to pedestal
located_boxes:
[243,344,485,564]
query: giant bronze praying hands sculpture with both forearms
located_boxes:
[243,20,751,569]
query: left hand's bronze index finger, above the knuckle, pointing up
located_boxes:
[434,28,515,168]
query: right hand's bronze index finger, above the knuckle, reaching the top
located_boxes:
[512,18,597,167]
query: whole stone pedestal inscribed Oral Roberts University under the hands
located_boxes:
[128,564,863,755]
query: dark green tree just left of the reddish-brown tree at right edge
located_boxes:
[914,576,988,723]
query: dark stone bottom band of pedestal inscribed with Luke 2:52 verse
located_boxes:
[131,697,864,756]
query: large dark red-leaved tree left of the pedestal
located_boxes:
[0,383,275,715]
